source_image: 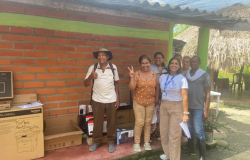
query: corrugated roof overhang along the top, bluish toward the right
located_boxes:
[2,0,250,31]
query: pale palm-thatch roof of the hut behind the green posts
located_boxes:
[175,4,250,70]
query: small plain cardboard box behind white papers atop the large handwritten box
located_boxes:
[12,93,37,104]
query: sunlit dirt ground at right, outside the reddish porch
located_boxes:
[144,95,250,160]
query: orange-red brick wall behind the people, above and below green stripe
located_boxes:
[0,0,168,117]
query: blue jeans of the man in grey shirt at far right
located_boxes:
[188,109,205,140]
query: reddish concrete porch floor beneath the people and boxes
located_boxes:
[37,138,161,160]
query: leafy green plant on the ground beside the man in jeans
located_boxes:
[203,109,228,132]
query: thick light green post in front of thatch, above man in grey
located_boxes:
[197,27,210,71]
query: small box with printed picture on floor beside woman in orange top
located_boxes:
[116,127,134,145]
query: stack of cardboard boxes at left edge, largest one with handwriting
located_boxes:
[0,72,44,160]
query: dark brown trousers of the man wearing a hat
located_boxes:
[92,100,117,145]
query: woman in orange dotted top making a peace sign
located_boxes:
[128,55,159,152]
